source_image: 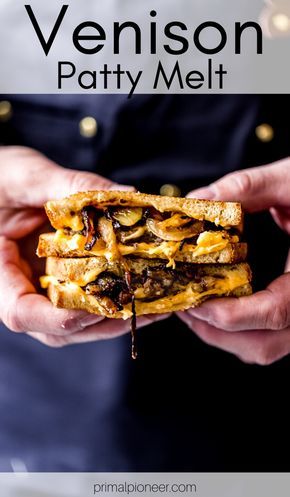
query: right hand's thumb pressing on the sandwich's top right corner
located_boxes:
[188,159,290,212]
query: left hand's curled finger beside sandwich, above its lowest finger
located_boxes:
[0,238,100,335]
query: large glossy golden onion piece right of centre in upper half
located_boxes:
[146,214,203,242]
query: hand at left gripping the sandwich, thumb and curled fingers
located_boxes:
[0,147,170,347]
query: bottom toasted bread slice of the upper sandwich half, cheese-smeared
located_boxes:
[37,233,247,264]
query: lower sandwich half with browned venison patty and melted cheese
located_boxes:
[41,257,252,319]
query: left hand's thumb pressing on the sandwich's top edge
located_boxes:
[0,149,134,208]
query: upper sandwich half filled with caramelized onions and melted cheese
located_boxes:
[37,191,247,266]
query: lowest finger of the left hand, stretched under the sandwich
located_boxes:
[28,313,170,347]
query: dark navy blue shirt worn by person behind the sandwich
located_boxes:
[0,95,290,471]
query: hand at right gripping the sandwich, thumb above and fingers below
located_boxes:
[178,159,290,365]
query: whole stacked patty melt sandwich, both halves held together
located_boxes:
[37,191,251,355]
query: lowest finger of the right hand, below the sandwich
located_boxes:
[177,312,290,365]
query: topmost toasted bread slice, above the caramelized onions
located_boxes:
[45,191,243,231]
